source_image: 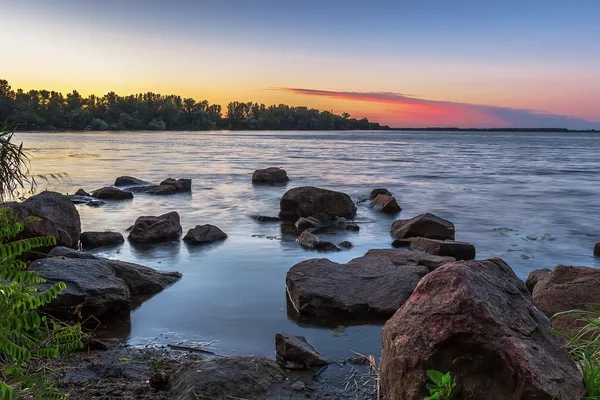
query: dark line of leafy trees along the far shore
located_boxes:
[0,80,389,130]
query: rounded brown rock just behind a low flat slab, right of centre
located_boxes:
[390,213,454,240]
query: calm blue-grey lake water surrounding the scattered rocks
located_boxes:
[18,132,600,358]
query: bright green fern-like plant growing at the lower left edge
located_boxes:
[0,208,83,400]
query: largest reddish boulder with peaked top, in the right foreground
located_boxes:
[381,259,585,400]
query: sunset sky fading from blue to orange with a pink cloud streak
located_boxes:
[0,0,600,129]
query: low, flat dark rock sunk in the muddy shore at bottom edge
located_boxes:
[170,356,285,399]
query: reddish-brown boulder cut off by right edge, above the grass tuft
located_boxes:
[533,265,600,333]
